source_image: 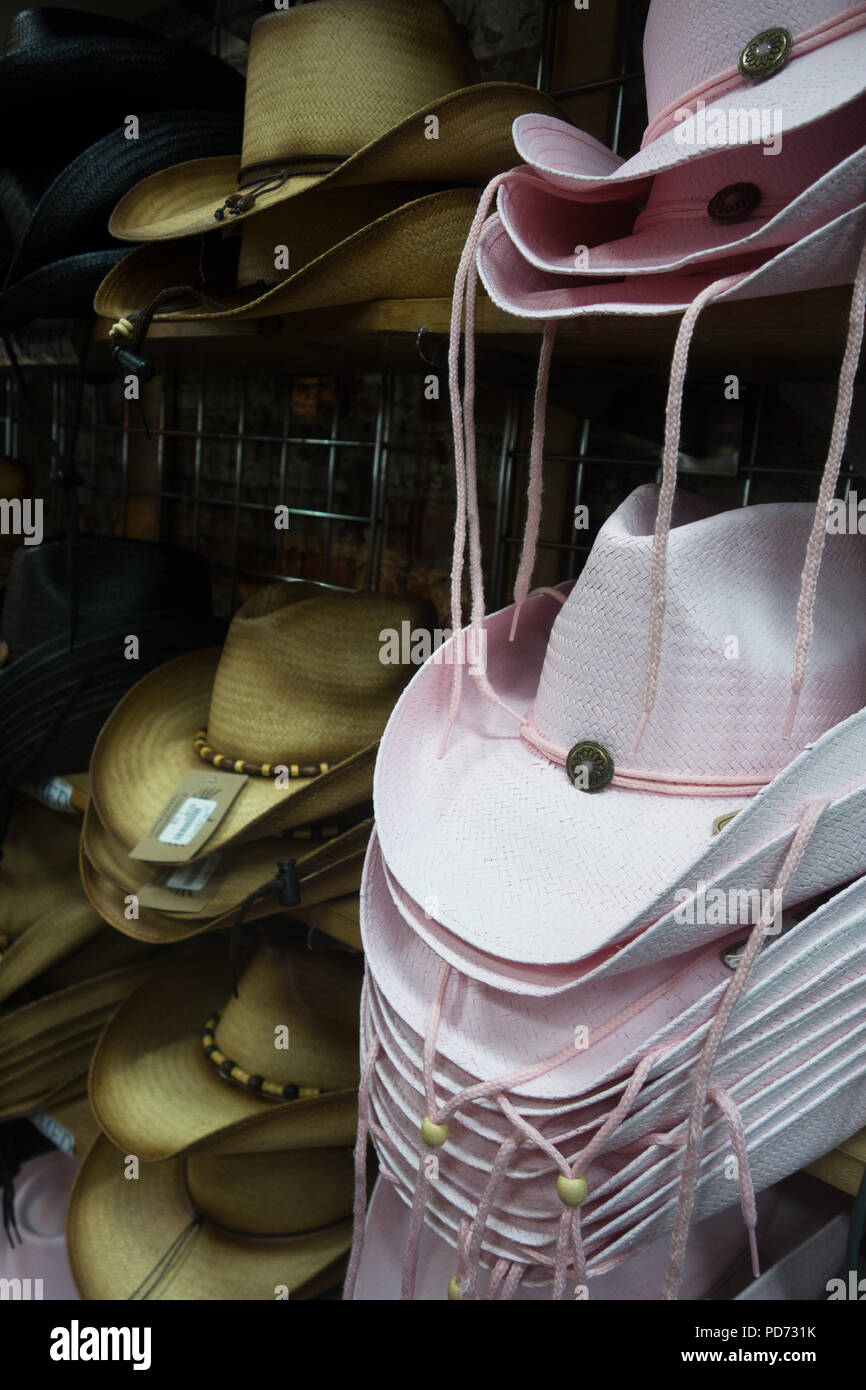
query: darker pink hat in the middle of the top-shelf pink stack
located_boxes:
[498,99,866,278]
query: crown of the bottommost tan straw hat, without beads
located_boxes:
[186,1148,354,1237]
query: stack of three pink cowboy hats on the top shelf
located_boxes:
[478,0,866,318]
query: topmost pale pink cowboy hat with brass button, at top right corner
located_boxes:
[514,0,866,196]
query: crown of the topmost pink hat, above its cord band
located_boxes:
[644,0,856,125]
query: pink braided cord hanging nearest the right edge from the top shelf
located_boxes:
[783,242,866,738]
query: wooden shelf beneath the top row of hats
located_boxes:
[6,286,851,382]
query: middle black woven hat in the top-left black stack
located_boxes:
[0,111,240,331]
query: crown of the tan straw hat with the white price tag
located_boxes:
[205,584,435,766]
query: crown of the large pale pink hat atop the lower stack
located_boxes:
[532,487,866,784]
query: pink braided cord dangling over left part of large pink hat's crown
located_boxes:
[631,274,745,758]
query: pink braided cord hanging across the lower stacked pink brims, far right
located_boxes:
[664,801,828,1300]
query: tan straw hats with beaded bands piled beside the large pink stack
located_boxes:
[61,584,435,1300]
